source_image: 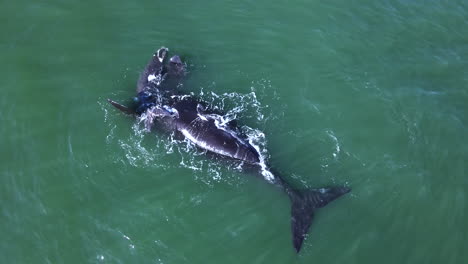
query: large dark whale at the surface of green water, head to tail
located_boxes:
[108,47,351,252]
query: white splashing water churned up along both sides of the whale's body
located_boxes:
[100,80,274,186]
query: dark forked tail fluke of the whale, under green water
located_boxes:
[289,187,351,252]
